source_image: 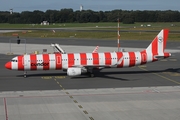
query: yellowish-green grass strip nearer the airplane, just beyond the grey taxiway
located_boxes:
[3,31,180,41]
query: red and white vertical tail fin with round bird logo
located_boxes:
[146,29,169,55]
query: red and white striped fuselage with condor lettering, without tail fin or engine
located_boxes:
[4,51,170,70]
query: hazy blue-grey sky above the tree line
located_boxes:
[0,0,180,12]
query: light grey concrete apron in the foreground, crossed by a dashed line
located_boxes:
[0,86,180,120]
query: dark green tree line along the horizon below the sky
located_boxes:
[0,9,180,24]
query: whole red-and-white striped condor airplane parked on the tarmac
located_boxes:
[5,29,171,77]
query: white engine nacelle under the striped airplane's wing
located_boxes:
[67,68,82,76]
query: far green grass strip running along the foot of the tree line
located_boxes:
[0,22,180,28]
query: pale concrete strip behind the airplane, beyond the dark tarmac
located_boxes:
[0,43,180,54]
